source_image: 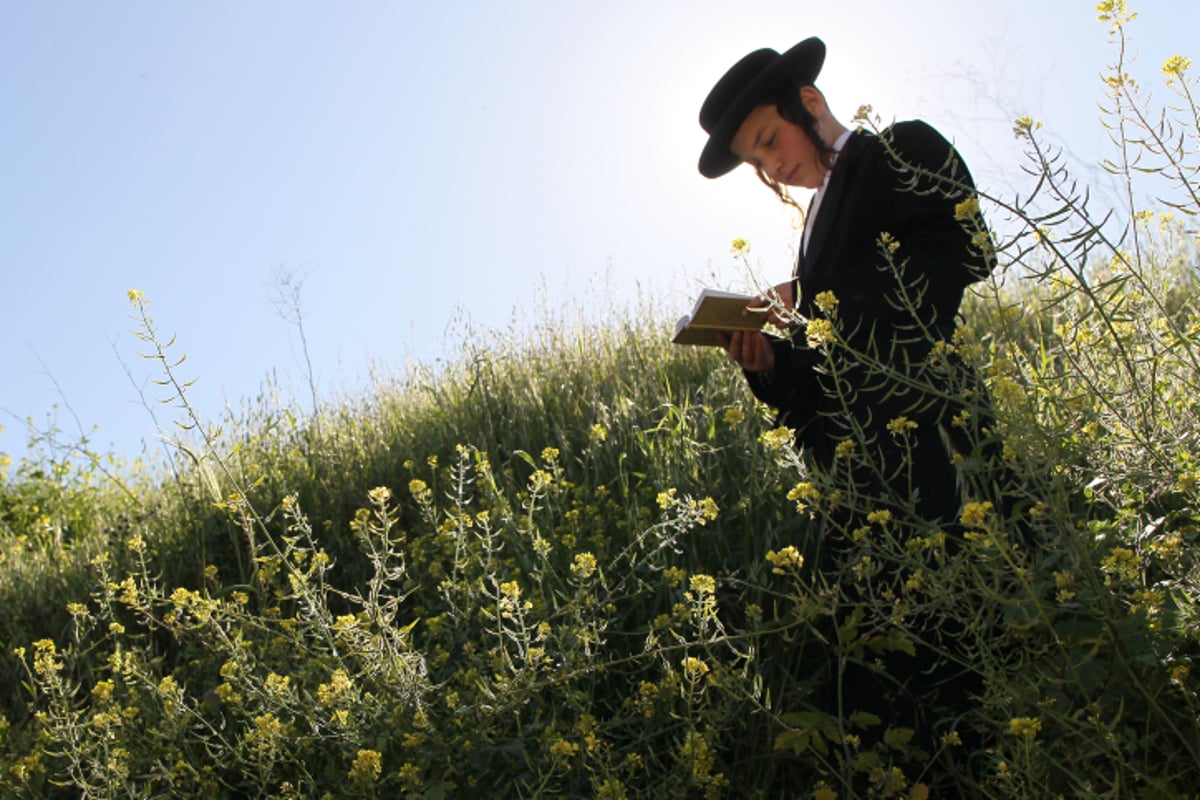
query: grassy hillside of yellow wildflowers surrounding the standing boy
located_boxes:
[0,2,1200,800]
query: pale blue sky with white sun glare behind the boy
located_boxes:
[0,0,1200,456]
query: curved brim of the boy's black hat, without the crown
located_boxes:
[700,36,826,178]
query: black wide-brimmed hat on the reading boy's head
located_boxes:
[700,36,824,178]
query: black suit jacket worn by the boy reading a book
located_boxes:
[746,121,994,474]
